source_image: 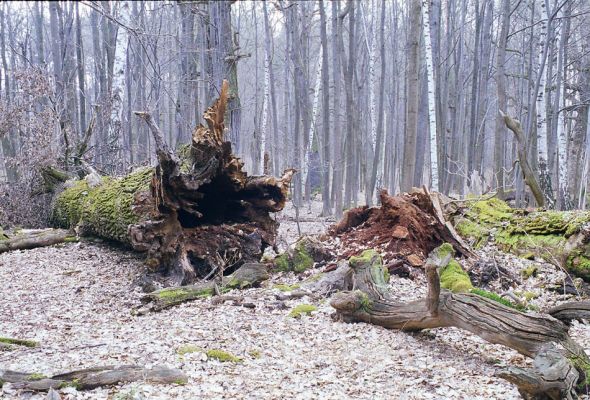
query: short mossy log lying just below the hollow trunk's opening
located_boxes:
[133,263,268,315]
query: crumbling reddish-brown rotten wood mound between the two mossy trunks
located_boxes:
[328,190,472,269]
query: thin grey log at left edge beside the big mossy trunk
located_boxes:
[0,229,77,254]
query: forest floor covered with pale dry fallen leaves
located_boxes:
[0,203,590,400]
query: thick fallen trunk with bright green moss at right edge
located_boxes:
[447,198,590,281]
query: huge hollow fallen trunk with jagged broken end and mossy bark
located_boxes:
[53,82,295,285]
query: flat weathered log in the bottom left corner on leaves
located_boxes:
[0,365,188,392]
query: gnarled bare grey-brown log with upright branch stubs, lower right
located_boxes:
[330,245,590,399]
